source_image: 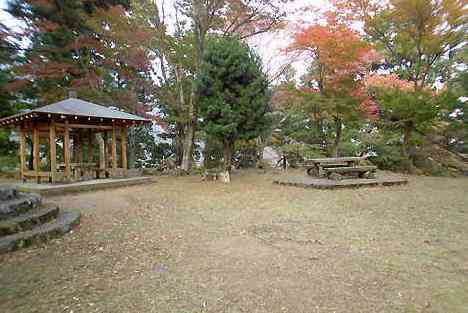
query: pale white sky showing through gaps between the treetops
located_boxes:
[0,0,327,81]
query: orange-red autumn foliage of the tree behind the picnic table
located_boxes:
[287,18,382,117]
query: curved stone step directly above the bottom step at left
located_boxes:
[0,204,59,237]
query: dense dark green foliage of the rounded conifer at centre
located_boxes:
[197,37,268,142]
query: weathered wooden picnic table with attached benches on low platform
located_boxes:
[304,156,377,180]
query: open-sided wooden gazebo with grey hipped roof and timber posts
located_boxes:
[0,98,151,183]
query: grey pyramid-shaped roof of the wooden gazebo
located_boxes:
[0,98,150,126]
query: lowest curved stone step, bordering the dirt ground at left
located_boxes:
[0,212,81,253]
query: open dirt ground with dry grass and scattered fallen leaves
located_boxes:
[0,171,468,313]
